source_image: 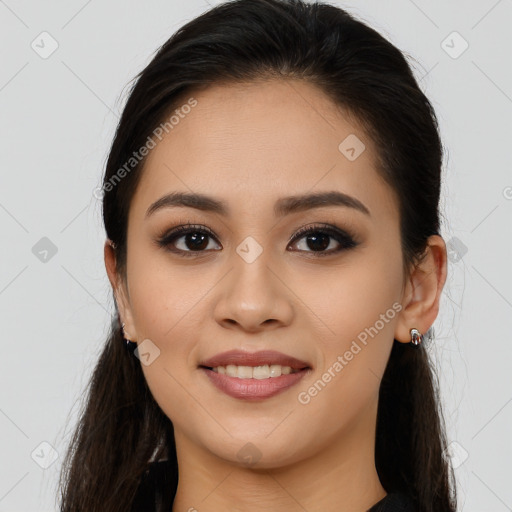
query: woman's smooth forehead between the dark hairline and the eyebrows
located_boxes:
[128,80,394,222]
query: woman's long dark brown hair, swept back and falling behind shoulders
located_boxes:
[60,0,456,512]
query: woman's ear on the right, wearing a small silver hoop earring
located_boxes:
[395,235,447,343]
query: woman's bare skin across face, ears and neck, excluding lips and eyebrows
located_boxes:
[105,80,446,512]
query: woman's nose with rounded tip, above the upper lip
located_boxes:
[214,253,294,332]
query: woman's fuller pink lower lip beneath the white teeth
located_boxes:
[200,367,309,400]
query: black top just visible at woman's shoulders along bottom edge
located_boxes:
[130,461,415,512]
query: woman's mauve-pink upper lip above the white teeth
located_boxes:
[199,350,310,370]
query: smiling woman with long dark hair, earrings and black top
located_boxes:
[61,0,456,512]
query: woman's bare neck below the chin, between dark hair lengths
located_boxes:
[172,396,386,512]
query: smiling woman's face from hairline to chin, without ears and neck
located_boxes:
[116,81,404,467]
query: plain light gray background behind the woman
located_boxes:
[0,0,512,512]
